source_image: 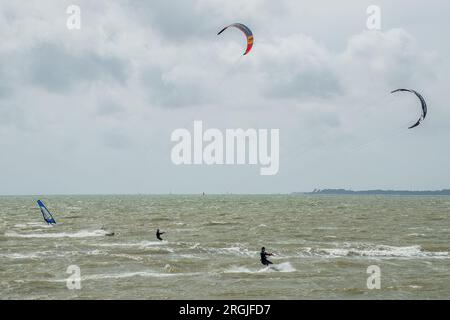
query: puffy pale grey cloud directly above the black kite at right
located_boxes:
[338,29,436,89]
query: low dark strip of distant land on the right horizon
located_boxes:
[292,189,450,196]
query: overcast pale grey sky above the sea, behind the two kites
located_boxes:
[0,0,450,194]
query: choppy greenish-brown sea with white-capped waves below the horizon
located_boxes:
[0,195,450,299]
